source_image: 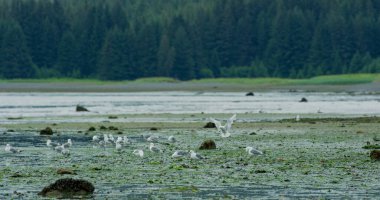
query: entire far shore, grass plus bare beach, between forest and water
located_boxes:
[0,74,380,93]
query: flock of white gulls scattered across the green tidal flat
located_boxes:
[5,114,264,159]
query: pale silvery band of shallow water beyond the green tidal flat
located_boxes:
[0,92,380,123]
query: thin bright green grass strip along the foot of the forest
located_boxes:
[0,74,380,85]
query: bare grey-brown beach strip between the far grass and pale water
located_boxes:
[0,82,380,93]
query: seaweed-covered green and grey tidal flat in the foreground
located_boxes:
[0,113,380,199]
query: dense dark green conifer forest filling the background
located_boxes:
[0,0,380,80]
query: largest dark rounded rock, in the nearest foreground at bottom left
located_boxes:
[38,178,95,198]
